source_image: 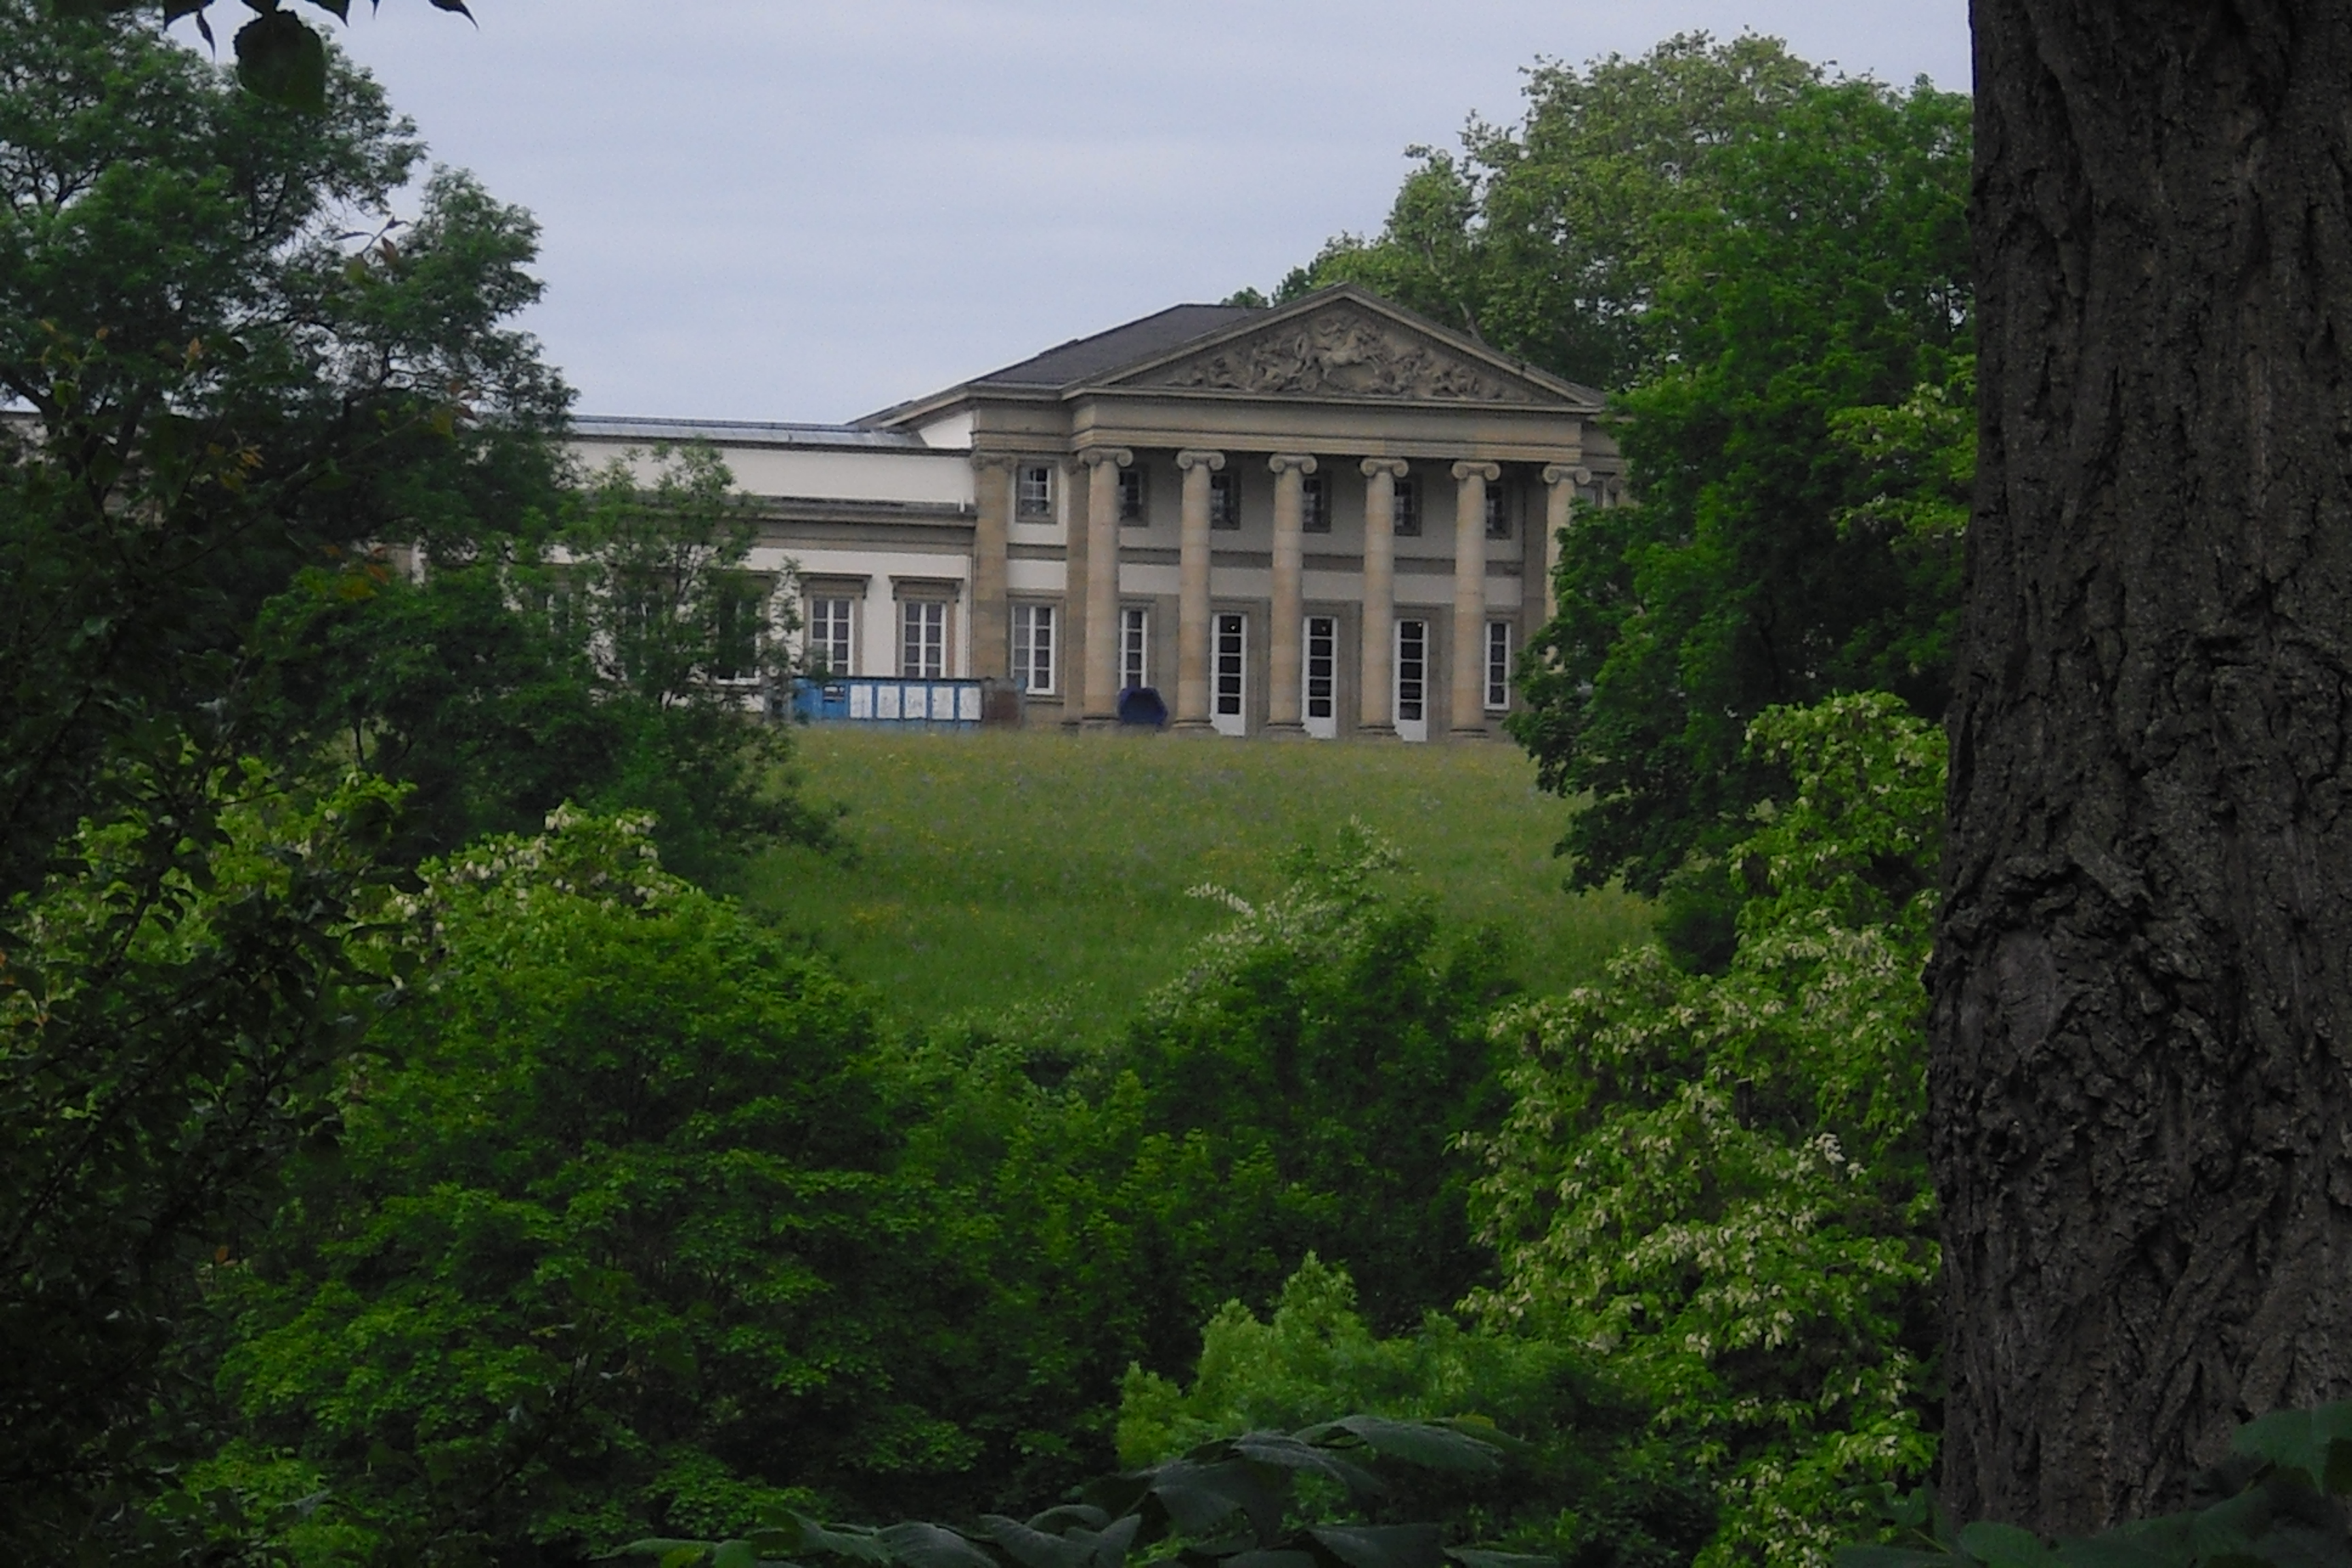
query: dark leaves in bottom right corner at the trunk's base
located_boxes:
[1837,1403,2352,1568]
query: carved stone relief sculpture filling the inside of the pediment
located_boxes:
[1139,310,1536,402]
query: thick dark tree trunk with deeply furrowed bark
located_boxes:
[1931,0,2352,1533]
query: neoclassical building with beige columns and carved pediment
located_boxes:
[576,284,1620,740]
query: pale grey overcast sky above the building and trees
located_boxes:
[252,0,1969,421]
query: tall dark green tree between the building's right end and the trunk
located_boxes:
[1512,70,1974,907]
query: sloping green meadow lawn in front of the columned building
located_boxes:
[748,726,1649,1032]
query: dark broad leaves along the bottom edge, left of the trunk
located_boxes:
[623,1415,1550,1568]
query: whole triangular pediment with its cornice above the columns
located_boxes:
[1098,287,1597,407]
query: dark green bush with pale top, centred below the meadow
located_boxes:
[1117,823,1503,1326]
